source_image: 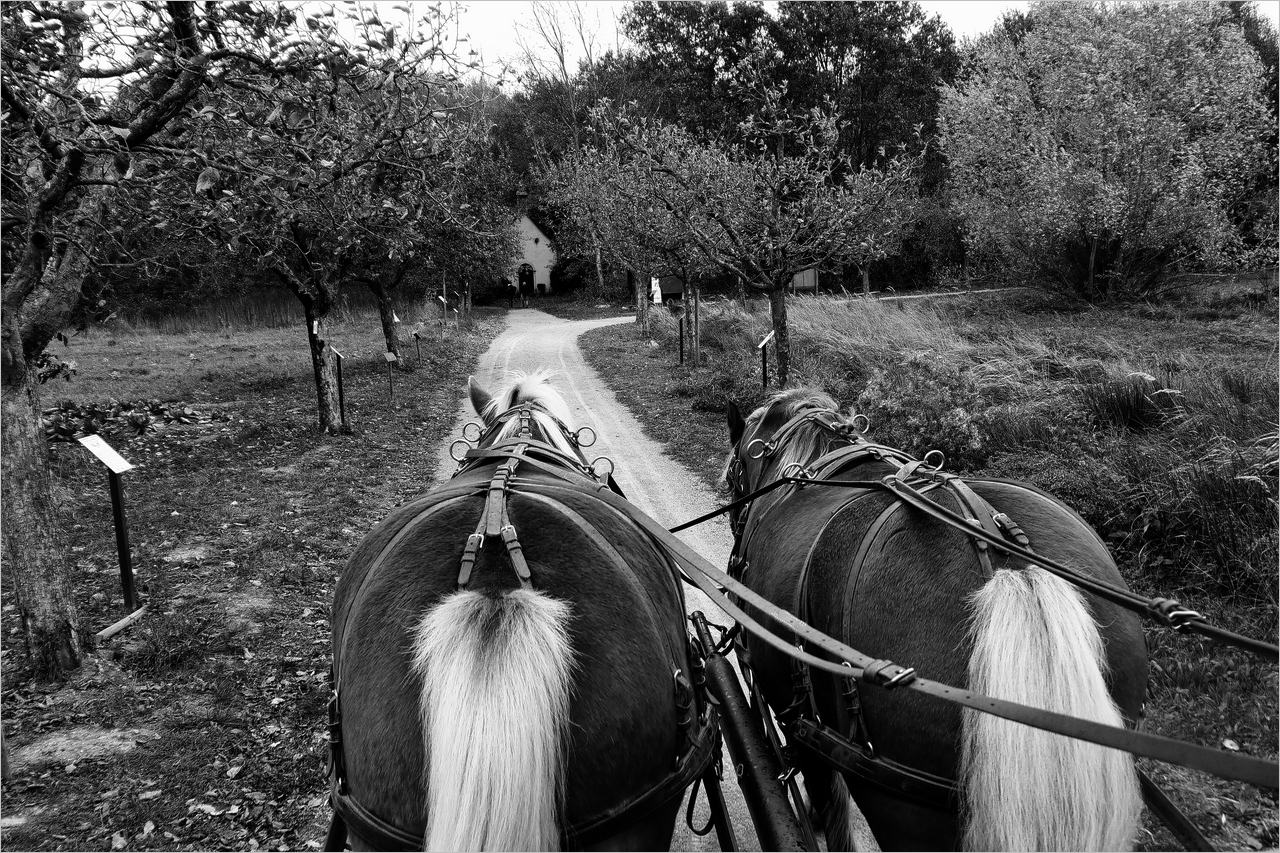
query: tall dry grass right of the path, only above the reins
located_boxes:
[652,297,1280,604]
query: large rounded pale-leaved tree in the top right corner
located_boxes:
[942,3,1270,300]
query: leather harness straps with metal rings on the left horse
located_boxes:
[325,403,719,850]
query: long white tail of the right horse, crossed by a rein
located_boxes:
[960,566,1142,850]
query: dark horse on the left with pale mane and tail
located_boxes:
[325,374,718,850]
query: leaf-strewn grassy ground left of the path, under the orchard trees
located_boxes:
[0,302,503,850]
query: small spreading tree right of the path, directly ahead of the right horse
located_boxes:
[596,87,923,384]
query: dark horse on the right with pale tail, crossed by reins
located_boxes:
[726,389,1147,850]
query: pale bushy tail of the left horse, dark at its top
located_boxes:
[413,589,573,850]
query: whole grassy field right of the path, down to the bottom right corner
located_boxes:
[581,278,1280,849]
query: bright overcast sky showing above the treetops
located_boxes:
[460,0,1280,78]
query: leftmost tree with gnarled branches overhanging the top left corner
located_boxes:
[0,1,343,676]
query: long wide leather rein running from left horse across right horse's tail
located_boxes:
[522,484,1280,789]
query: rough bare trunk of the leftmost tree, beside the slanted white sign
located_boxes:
[0,356,83,678]
